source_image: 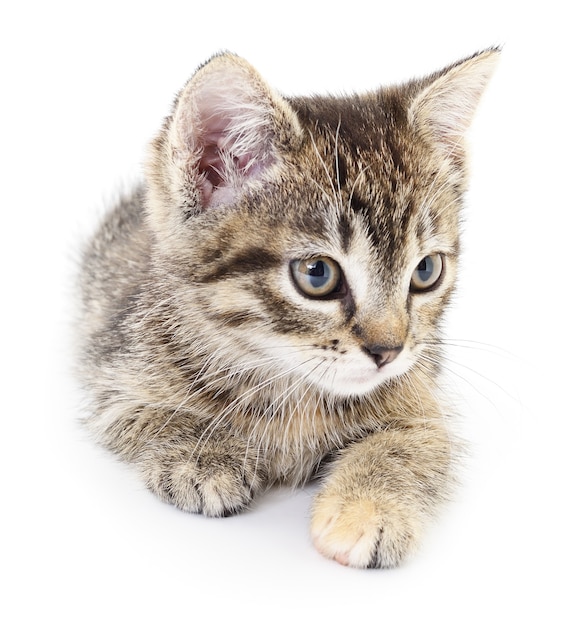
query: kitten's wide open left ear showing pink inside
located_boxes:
[148,54,302,219]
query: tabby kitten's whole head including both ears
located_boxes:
[147,50,498,397]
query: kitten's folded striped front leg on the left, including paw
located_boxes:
[94,409,267,517]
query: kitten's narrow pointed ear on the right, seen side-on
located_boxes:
[409,48,500,160]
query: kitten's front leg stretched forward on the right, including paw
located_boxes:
[312,425,451,567]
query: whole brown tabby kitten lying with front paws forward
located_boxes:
[76,49,498,567]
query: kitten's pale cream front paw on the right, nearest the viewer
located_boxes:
[312,491,421,567]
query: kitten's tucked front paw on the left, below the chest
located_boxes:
[140,438,266,517]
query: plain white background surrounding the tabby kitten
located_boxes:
[0,0,583,625]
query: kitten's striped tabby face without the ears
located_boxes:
[173,120,459,397]
